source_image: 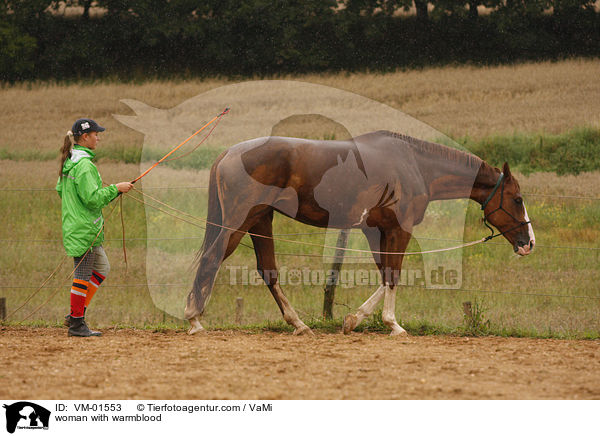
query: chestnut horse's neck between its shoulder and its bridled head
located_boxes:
[419,152,498,204]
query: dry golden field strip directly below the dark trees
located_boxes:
[0,60,600,151]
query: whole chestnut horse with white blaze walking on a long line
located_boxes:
[185,131,535,335]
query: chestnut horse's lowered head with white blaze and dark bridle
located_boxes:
[482,163,535,256]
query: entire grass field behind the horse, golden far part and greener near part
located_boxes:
[0,60,600,338]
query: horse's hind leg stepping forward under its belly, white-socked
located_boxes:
[249,213,313,335]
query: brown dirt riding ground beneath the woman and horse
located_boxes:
[0,327,600,400]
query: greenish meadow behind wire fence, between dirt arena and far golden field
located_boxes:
[0,161,600,337]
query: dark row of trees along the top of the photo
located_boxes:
[0,0,600,81]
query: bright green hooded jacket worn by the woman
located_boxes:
[56,144,119,257]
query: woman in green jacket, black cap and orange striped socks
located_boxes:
[56,118,133,337]
